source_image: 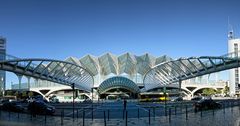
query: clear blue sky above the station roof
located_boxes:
[0,0,240,88]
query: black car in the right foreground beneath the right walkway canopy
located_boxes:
[194,99,221,112]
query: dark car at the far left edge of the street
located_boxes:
[1,101,24,112]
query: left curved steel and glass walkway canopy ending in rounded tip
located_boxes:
[0,55,94,92]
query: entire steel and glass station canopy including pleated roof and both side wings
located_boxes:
[0,50,240,94]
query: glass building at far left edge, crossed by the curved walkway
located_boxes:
[0,37,6,95]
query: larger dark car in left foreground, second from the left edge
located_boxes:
[28,100,55,115]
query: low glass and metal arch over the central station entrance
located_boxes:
[98,76,140,94]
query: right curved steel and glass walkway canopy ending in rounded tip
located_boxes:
[143,53,240,91]
